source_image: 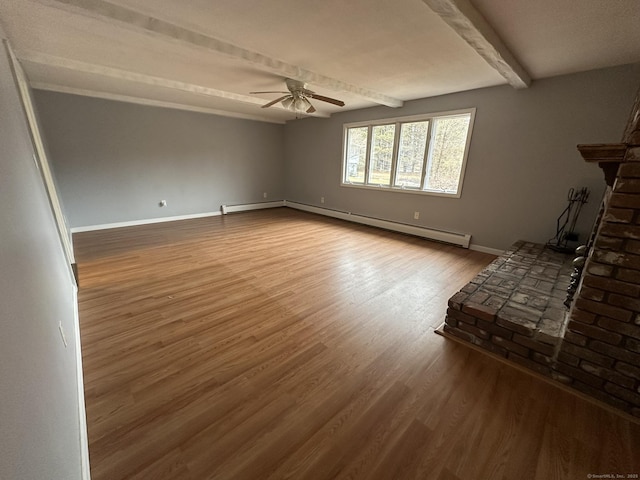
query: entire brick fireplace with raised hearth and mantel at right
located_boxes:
[443,88,640,417]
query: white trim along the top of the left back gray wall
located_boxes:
[30,82,285,124]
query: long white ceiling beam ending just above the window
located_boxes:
[39,0,403,107]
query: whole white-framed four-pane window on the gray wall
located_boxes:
[342,109,475,197]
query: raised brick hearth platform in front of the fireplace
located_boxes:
[444,241,573,375]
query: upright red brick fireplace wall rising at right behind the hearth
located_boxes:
[555,147,640,416]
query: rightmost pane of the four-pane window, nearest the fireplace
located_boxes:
[425,114,471,193]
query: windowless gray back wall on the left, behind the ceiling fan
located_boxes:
[35,91,284,231]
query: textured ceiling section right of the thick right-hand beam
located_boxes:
[473,0,640,78]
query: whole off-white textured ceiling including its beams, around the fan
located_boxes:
[0,0,640,122]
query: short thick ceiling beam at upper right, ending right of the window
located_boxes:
[422,0,531,88]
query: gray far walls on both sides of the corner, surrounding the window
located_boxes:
[35,64,640,249]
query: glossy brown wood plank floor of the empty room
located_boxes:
[74,208,640,480]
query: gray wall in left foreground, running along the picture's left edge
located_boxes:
[0,45,81,480]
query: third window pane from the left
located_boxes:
[395,121,429,188]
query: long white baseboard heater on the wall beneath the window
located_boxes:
[284,200,471,248]
